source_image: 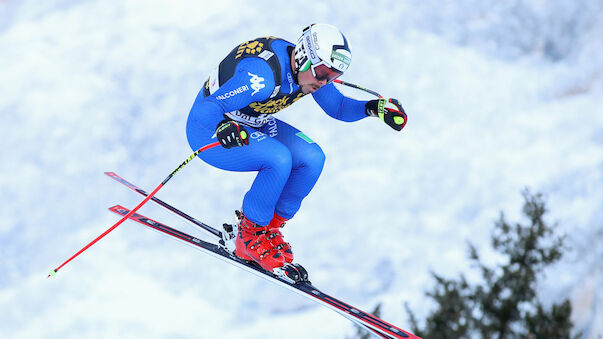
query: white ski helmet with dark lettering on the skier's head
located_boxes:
[295,24,352,82]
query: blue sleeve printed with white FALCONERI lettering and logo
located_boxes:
[189,57,275,129]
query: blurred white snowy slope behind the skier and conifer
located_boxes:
[0,0,603,338]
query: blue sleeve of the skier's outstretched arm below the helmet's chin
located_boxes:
[312,84,367,122]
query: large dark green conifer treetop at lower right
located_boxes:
[406,190,572,339]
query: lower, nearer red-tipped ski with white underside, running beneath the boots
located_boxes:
[109,205,419,338]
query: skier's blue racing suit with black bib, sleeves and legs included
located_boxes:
[186,37,367,225]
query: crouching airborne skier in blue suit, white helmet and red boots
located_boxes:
[186,24,407,271]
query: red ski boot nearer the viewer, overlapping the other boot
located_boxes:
[235,213,285,272]
